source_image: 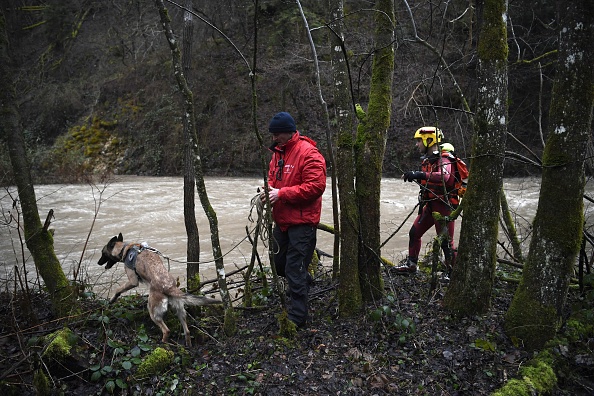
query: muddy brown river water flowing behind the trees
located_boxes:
[0,176,594,295]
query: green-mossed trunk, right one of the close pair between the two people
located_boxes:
[355,0,395,300]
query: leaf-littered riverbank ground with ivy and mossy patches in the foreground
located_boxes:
[0,268,594,395]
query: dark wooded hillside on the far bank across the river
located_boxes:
[0,0,572,184]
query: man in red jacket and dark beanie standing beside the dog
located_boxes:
[262,112,326,327]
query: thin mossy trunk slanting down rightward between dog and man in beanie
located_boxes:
[155,0,237,335]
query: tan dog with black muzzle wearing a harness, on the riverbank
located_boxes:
[98,233,221,347]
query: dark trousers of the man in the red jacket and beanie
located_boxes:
[272,225,316,326]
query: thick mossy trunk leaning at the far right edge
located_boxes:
[505,0,594,349]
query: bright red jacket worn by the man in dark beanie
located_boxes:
[268,131,326,231]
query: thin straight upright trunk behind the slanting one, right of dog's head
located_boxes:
[182,0,200,290]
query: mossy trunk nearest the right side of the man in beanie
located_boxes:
[329,0,362,317]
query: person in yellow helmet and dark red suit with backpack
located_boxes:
[394,126,457,274]
